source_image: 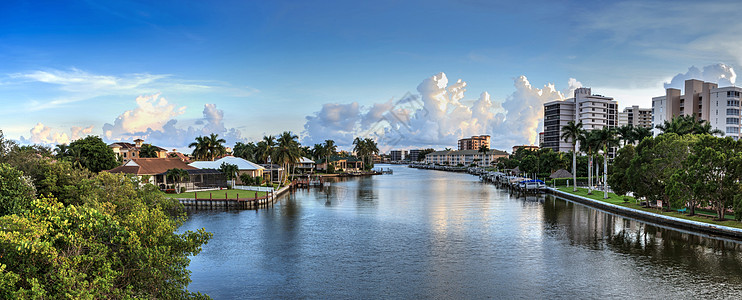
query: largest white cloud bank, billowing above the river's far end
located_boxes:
[302,73,582,152]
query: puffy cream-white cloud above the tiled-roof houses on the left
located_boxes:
[103,94,243,149]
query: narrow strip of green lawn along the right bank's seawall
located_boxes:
[557,186,742,228]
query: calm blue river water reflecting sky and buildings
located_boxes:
[182,166,742,299]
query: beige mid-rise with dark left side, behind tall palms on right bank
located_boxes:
[542,88,618,152]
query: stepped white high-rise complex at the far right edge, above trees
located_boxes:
[652,79,742,140]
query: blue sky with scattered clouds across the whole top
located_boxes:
[0,0,742,149]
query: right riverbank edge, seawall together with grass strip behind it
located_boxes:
[546,187,742,240]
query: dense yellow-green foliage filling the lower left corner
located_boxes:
[0,137,211,299]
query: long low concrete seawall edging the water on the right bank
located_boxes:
[548,188,742,240]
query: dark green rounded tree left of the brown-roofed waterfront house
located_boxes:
[69,135,118,173]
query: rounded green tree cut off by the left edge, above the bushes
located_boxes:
[0,163,36,216]
